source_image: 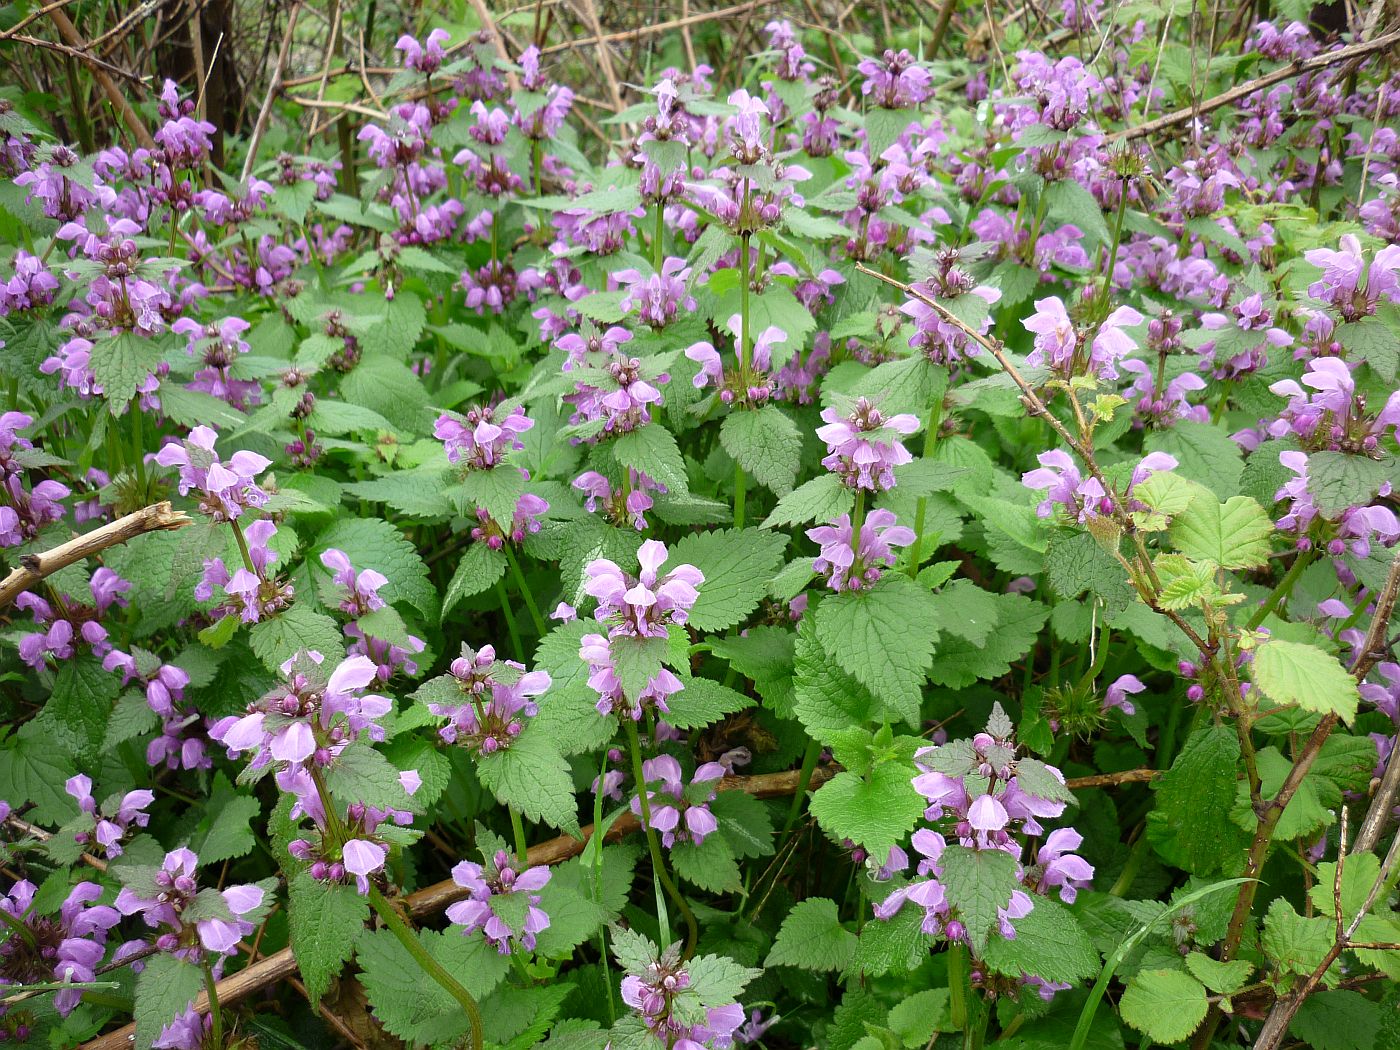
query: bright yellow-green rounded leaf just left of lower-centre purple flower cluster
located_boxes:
[809,762,927,862]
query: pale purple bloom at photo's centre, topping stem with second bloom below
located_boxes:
[584,539,704,638]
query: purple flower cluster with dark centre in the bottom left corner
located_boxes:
[0,879,122,1016]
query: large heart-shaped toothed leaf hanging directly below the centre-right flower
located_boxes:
[816,574,937,725]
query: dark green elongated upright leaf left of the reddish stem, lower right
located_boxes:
[1147,725,1239,875]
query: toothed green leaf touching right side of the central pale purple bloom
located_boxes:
[662,528,788,631]
